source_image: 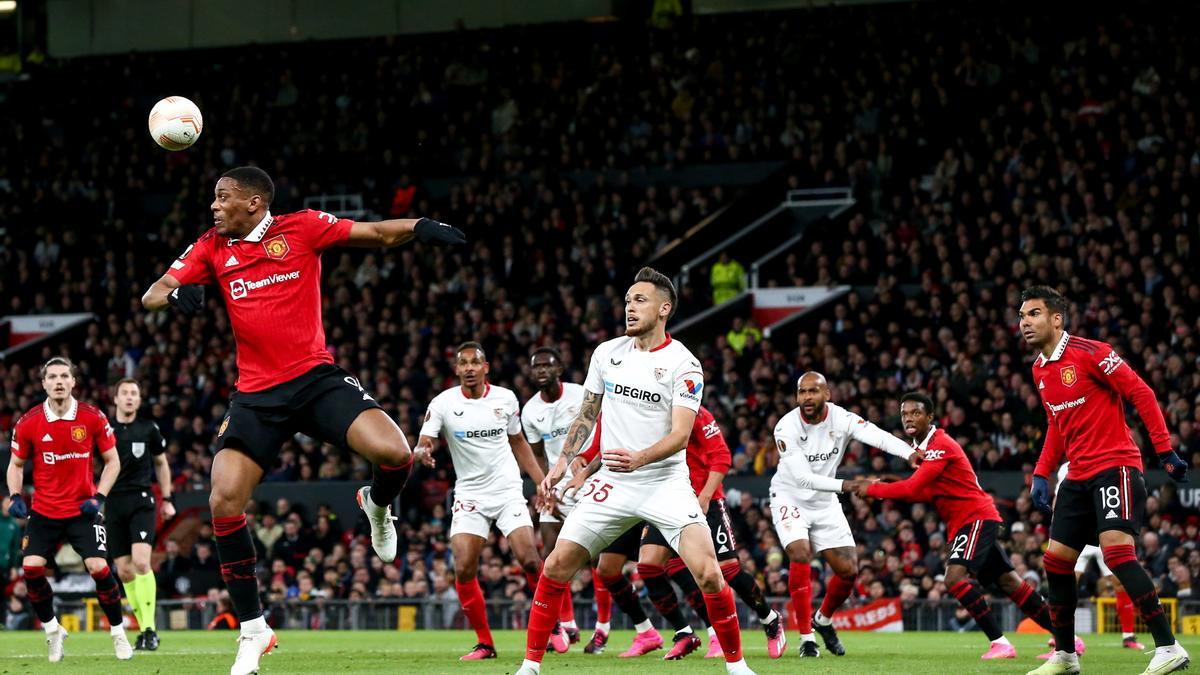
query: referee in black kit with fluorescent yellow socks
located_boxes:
[104,377,175,651]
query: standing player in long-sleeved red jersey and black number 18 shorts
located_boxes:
[1019,286,1189,675]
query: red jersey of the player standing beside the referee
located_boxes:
[12,399,116,518]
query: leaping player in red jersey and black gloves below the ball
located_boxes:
[142,167,467,675]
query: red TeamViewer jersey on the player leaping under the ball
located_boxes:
[167,210,354,392]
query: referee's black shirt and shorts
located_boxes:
[104,418,167,558]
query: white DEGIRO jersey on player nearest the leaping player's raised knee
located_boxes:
[421,384,522,495]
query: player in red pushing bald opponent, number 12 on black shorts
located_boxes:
[842,392,1050,659]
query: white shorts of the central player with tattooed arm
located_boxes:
[558,474,712,557]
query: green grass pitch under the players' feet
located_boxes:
[0,631,1185,675]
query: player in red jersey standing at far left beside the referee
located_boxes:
[7,357,133,663]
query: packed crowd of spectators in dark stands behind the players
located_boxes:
[0,0,1200,624]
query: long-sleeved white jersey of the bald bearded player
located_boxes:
[770,404,913,508]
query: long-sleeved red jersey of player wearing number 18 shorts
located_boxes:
[1033,333,1171,480]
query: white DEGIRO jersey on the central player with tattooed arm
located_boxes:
[583,335,704,484]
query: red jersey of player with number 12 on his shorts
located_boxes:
[866,428,1001,534]
